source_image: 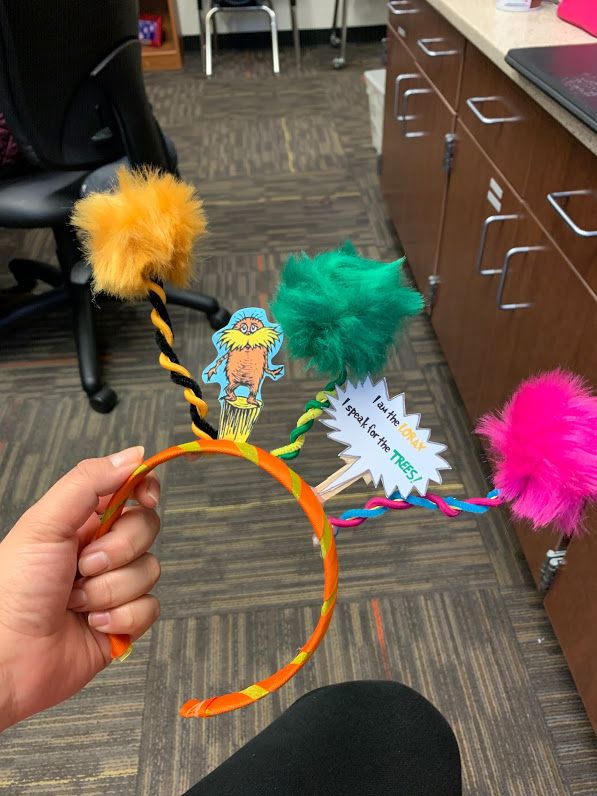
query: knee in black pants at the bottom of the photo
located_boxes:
[185,681,461,796]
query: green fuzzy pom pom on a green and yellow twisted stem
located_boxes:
[271,243,424,378]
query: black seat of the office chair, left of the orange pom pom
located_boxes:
[0,171,88,229]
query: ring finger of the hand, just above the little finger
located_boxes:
[67,553,160,611]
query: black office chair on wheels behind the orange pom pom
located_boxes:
[0,0,230,412]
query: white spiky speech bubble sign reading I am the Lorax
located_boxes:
[322,376,450,497]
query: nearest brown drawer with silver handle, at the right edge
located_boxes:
[526,104,597,293]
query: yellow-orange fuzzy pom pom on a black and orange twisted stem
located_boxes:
[71,166,207,299]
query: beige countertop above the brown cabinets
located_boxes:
[427,0,597,155]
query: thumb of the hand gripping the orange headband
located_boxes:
[23,446,144,542]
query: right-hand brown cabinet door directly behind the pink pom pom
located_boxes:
[477,216,597,581]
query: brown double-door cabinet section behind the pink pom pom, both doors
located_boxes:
[432,122,597,580]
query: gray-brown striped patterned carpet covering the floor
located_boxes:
[0,40,597,796]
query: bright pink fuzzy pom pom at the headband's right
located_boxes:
[477,370,597,536]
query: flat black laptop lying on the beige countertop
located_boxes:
[506,43,597,132]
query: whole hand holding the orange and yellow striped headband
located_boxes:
[0,448,160,730]
